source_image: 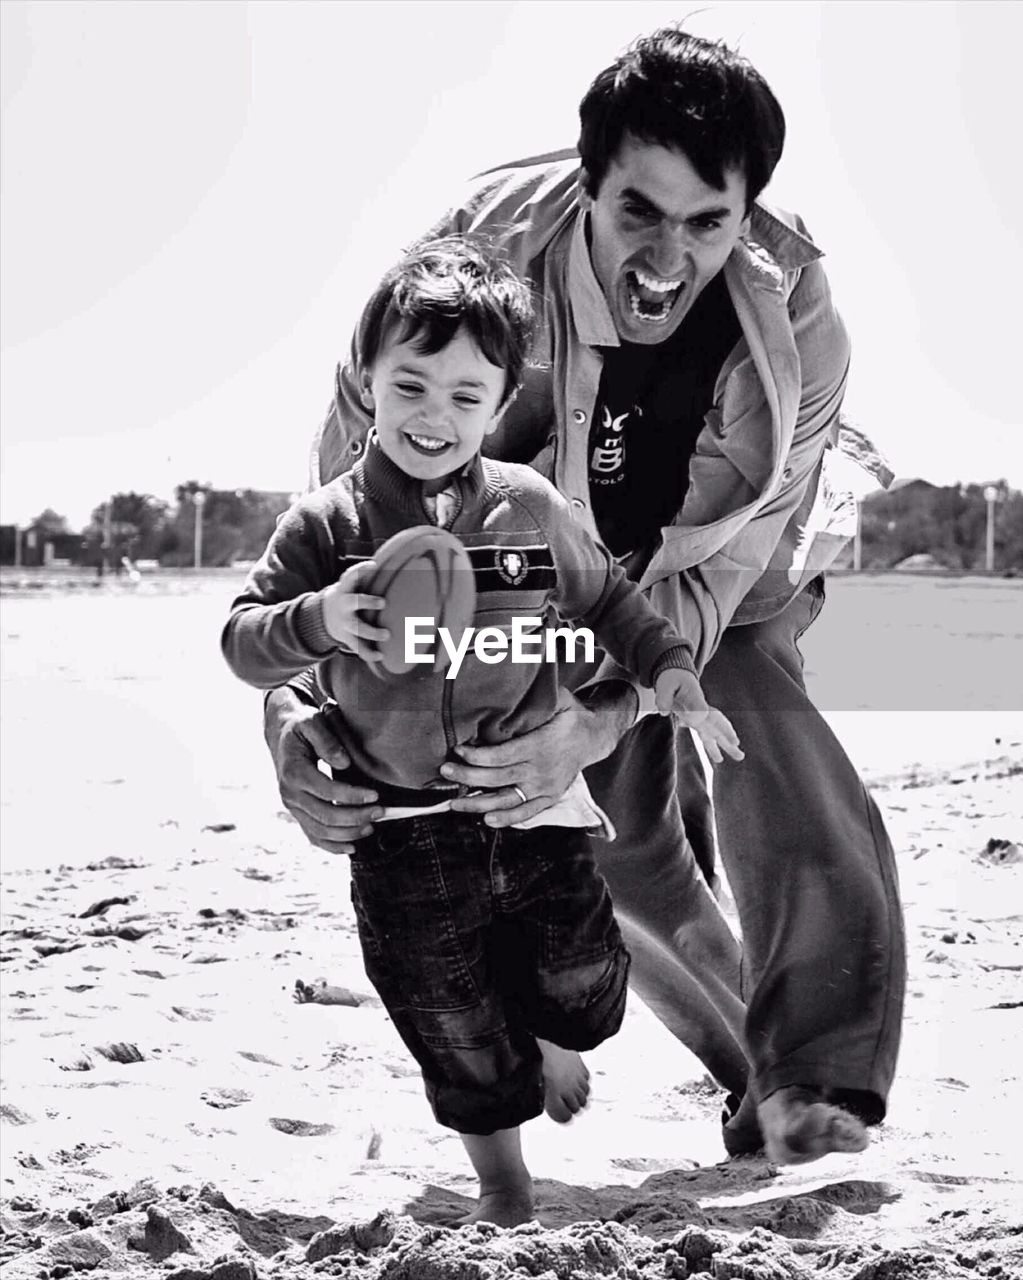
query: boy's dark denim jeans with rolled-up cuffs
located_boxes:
[352,813,629,1134]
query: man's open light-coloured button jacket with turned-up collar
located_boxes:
[310,152,891,668]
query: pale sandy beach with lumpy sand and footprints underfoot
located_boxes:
[0,575,1023,1280]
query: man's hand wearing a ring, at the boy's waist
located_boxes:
[440,681,636,827]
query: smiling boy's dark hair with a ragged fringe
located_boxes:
[358,236,534,403]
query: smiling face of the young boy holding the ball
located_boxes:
[362,329,507,480]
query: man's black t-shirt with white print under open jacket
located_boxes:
[589,274,741,561]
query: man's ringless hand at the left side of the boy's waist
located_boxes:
[264,687,382,854]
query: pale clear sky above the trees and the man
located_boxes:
[0,0,1023,527]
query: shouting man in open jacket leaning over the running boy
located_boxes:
[266,28,905,1162]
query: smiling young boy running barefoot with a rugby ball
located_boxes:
[223,238,741,1225]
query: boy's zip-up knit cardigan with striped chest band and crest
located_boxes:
[222,439,694,788]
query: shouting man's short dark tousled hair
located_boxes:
[579,27,785,211]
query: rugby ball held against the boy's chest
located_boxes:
[365,525,476,676]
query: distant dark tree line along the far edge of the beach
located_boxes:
[0,480,1023,573]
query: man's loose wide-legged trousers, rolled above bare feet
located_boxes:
[586,579,905,1123]
